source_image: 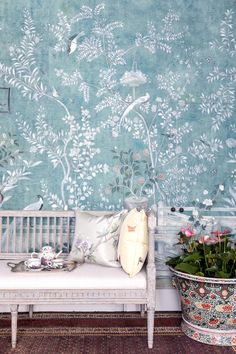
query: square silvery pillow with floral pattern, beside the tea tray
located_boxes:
[68,210,128,267]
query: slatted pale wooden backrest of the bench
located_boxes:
[0,210,125,259]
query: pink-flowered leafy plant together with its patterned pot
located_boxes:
[166,187,236,346]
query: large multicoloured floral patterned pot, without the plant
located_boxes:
[170,268,236,346]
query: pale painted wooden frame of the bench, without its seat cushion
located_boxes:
[0,210,156,348]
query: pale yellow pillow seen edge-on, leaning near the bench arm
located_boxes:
[118,209,148,277]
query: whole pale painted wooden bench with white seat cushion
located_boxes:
[0,210,156,348]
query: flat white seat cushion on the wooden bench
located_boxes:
[0,260,146,290]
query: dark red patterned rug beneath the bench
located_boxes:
[0,312,236,354]
